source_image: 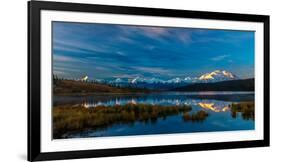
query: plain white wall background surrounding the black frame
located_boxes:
[0,0,281,162]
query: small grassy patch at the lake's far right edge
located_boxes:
[231,102,255,120]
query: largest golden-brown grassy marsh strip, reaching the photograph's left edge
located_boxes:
[53,104,192,139]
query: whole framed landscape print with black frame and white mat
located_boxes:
[28,1,269,161]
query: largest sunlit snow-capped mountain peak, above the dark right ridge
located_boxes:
[198,70,238,82]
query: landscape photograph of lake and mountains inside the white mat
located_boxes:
[51,21,255,139]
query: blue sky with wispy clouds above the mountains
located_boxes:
[52,22,254,79]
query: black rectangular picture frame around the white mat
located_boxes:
[28,1,270,161]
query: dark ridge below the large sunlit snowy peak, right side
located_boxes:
[171,78,255,92]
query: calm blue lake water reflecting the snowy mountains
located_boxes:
[53,92,255,138]
